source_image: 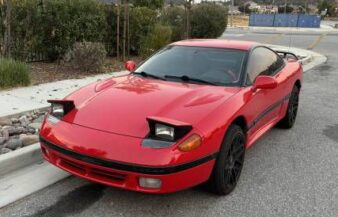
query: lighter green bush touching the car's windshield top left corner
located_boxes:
[141,24,172,57]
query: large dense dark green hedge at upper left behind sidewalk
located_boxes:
[7,0,107,60]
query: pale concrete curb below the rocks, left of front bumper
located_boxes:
[0,143,43,178]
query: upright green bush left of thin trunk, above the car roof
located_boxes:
[160,6,185,41]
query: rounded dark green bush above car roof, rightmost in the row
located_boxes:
[191,3,227,38]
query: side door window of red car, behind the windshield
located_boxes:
[247,47,284,84]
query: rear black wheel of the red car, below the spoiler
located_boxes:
[277,85,299,129]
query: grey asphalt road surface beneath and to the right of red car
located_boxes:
[0,29,338,217]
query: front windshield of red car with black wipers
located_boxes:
[135,46,246,86]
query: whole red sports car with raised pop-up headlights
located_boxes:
[40,39,303,195]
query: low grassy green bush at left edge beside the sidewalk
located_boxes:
[0,58,30,88]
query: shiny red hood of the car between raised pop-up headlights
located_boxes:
[64,75,239,137]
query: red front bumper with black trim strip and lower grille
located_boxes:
[40,138,216,193]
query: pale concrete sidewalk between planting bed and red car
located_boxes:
[0,73,125,117]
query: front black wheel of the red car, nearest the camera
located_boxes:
[206,125,246,195]
